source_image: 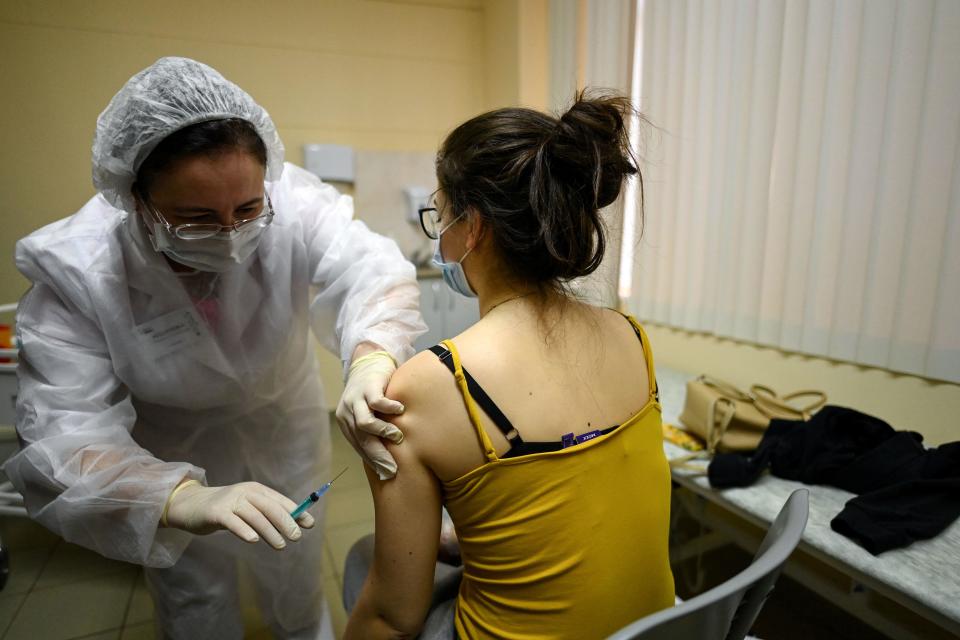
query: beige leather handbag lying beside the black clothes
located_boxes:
[680,375,827,455]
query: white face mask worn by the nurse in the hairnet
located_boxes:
[150,222,266,273]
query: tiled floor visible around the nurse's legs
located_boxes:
[0,427,373,640]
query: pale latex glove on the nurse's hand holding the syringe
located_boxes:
[161,480,314,549]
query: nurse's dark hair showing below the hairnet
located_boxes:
[134,118,267,196]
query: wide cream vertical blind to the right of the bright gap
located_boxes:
[621,0,960,382]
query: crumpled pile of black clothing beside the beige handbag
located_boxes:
[708,406,960,555]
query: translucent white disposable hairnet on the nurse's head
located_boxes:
[93,58,283,212]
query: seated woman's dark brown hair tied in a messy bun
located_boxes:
[437,92,643,290]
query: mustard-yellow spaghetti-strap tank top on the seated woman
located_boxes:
[443,318,674,640]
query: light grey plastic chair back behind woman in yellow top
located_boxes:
[607,489,810,640]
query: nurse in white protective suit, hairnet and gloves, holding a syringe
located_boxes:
[5,58,425,638]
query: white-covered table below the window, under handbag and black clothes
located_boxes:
[657,367,960,637]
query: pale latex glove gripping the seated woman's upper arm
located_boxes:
[337,351,403,480]
